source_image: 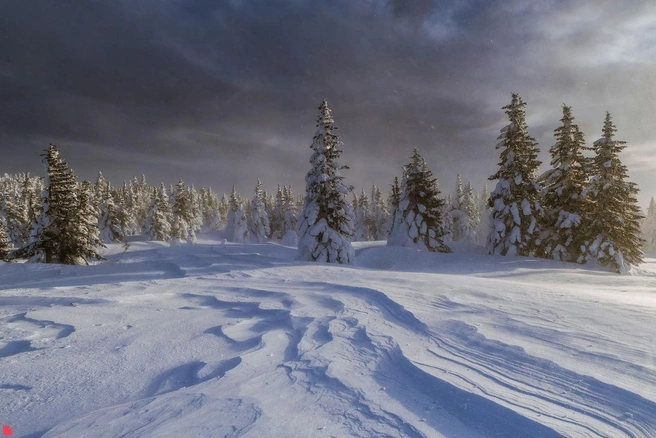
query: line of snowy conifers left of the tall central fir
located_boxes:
[0,145,302,264]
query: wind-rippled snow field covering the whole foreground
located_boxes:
[0,238,656,438]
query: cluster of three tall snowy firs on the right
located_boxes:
[487,93,643,273]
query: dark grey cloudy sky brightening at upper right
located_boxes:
[0,0,656,204]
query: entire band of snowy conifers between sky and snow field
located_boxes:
[0,94,656,272]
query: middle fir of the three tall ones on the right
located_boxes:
[541,105,592,262]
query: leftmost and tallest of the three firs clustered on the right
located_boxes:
[487,93,544,256]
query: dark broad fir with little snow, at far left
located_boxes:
[14,145,102,264]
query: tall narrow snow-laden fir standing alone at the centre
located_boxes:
[298,100,355,264]
